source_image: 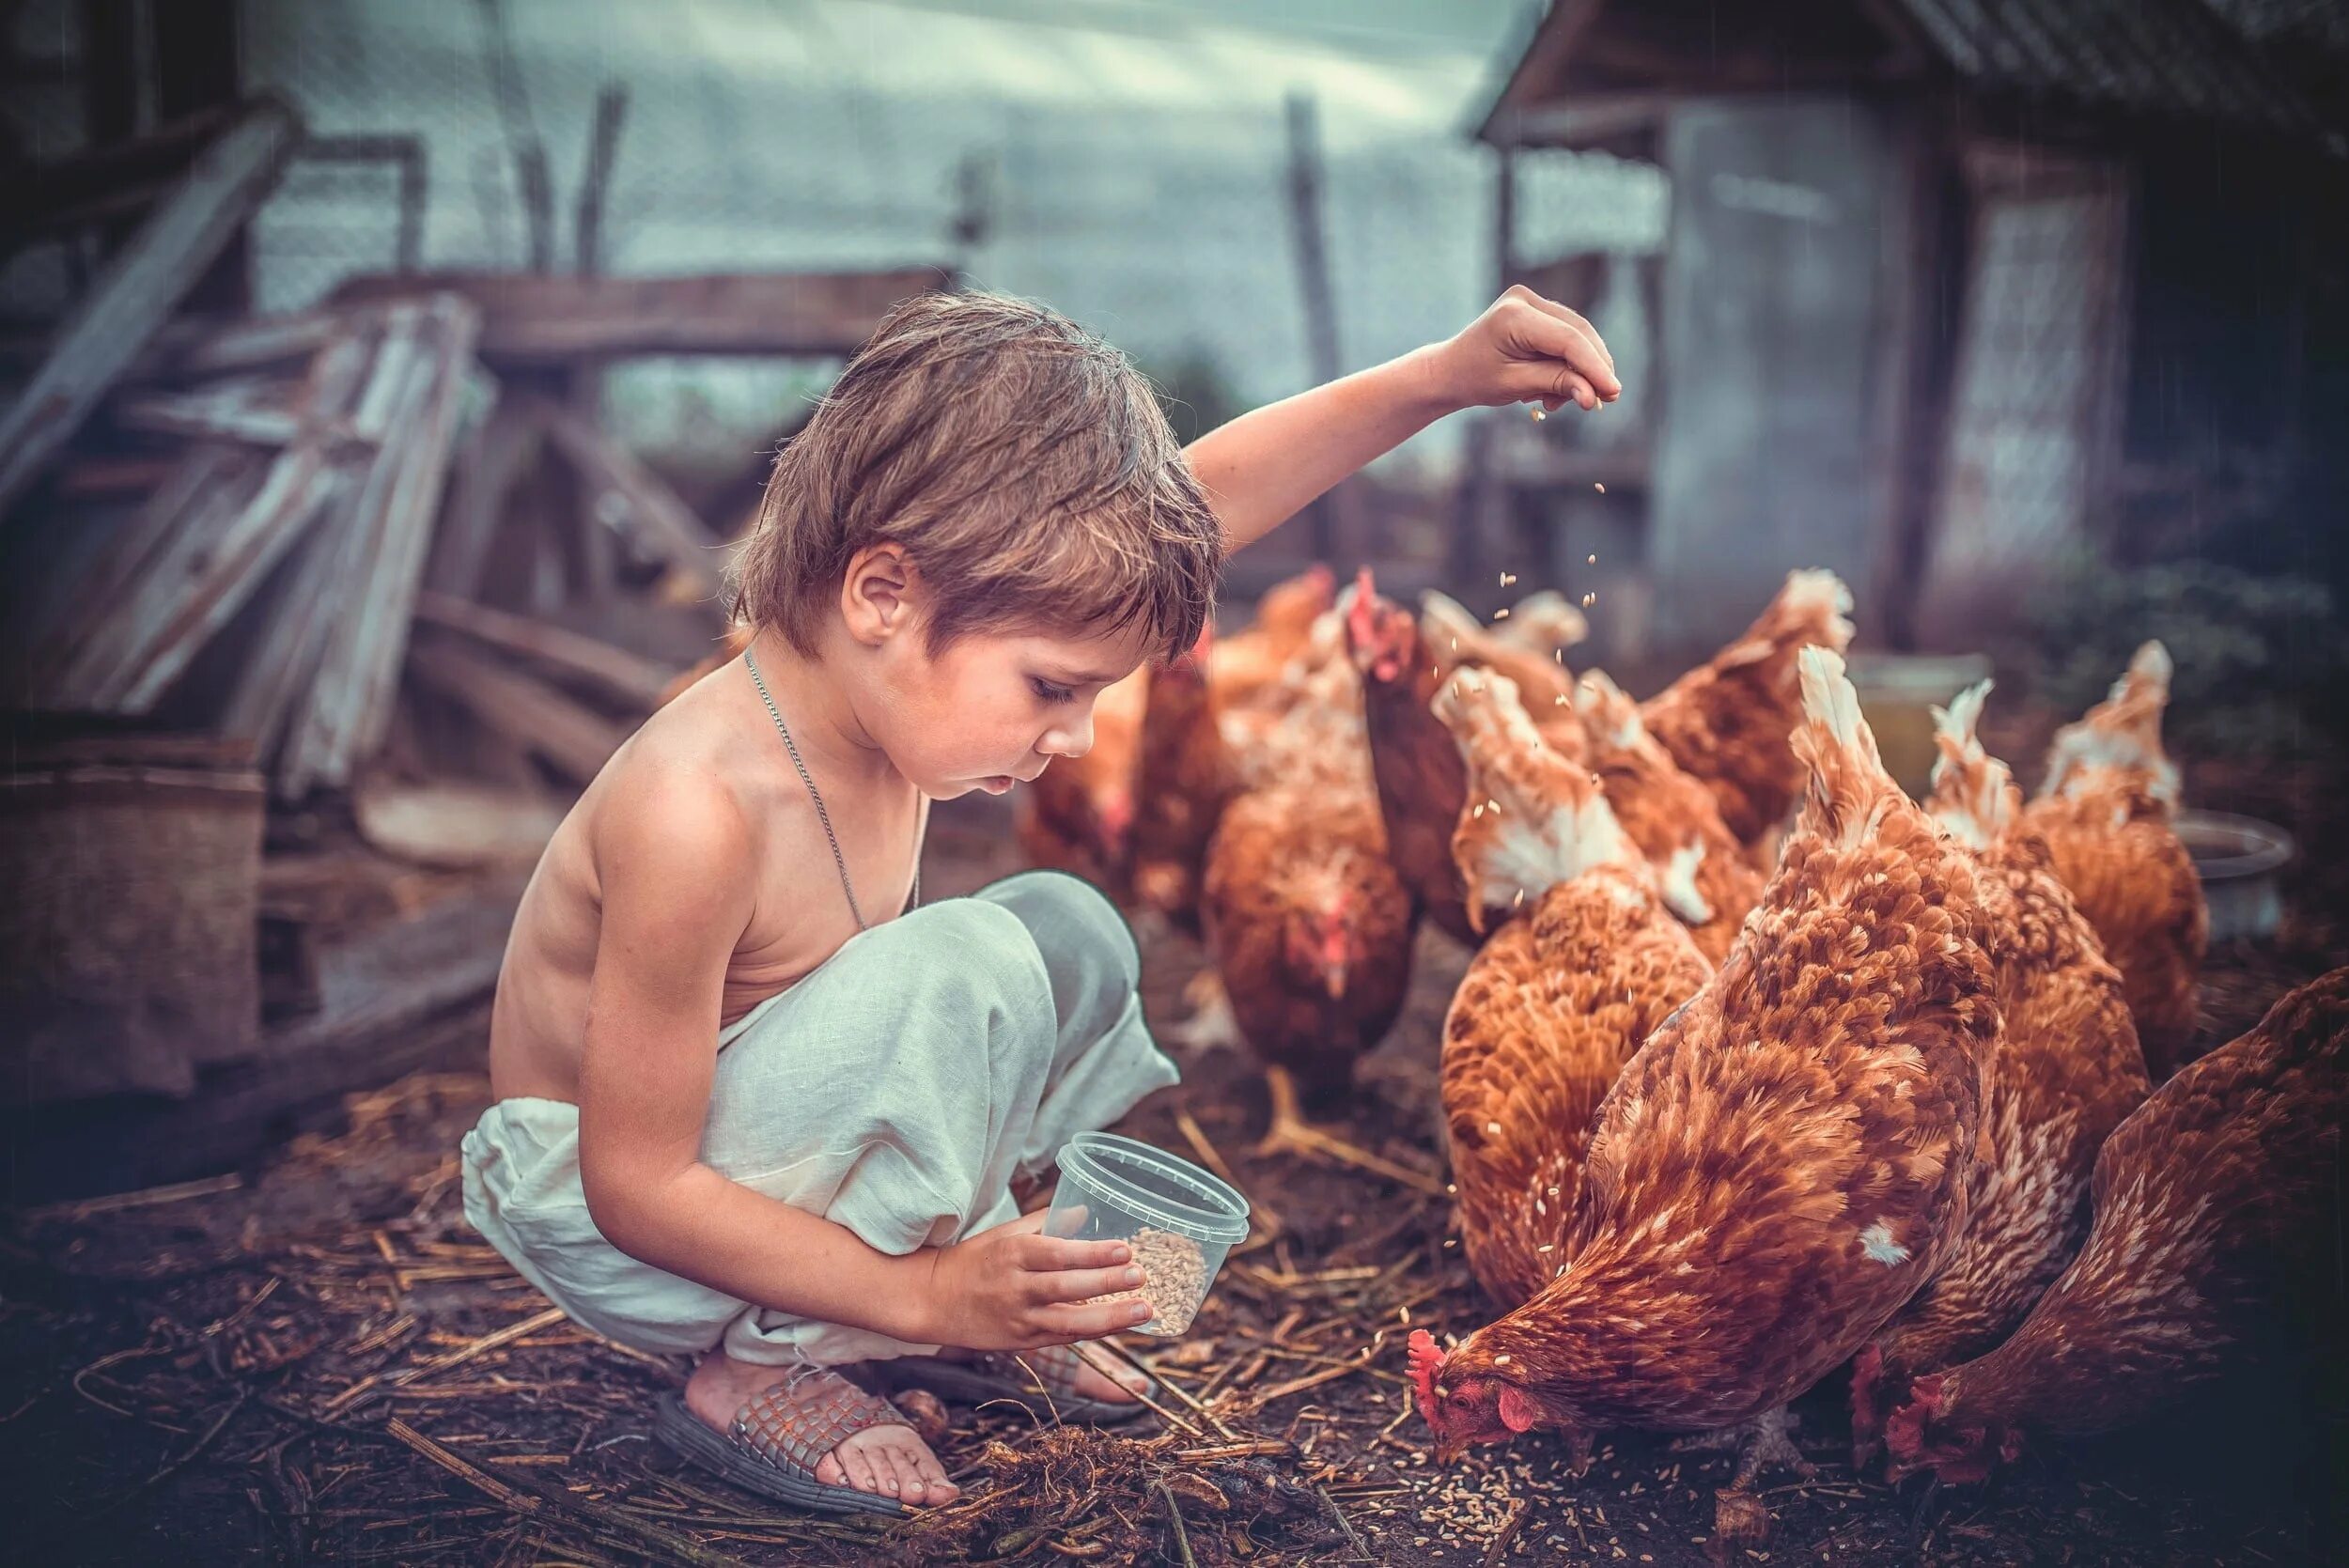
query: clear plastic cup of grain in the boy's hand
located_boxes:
[1043,1131,1248,1338]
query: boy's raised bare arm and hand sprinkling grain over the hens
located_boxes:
[1189,284,1624,550]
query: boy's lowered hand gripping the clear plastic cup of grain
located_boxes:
[928,1209,1151,1350]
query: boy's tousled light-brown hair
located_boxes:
[733,293,1224,658]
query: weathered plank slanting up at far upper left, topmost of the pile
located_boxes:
[0,99,301,509]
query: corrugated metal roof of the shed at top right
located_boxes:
[1898,0,2333,132]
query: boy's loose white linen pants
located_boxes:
[463,871,1177,1366]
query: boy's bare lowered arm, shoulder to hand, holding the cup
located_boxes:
[581,777,1149,1350]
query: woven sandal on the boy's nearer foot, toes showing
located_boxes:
[653,1366,914,1516]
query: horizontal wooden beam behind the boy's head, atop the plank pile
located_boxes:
[334,265,954,368]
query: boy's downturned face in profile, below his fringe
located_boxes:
[864,629,1149,800]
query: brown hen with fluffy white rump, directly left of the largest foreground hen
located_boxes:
[1436,669,1713,1308]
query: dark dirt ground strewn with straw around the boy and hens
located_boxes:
[0,737,2349,1568]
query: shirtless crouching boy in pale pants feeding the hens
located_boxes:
[463,288,1621,1514]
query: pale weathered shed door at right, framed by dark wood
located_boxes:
[1920,147,2128,648]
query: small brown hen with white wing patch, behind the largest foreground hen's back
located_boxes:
[1574,672,1765,965]
